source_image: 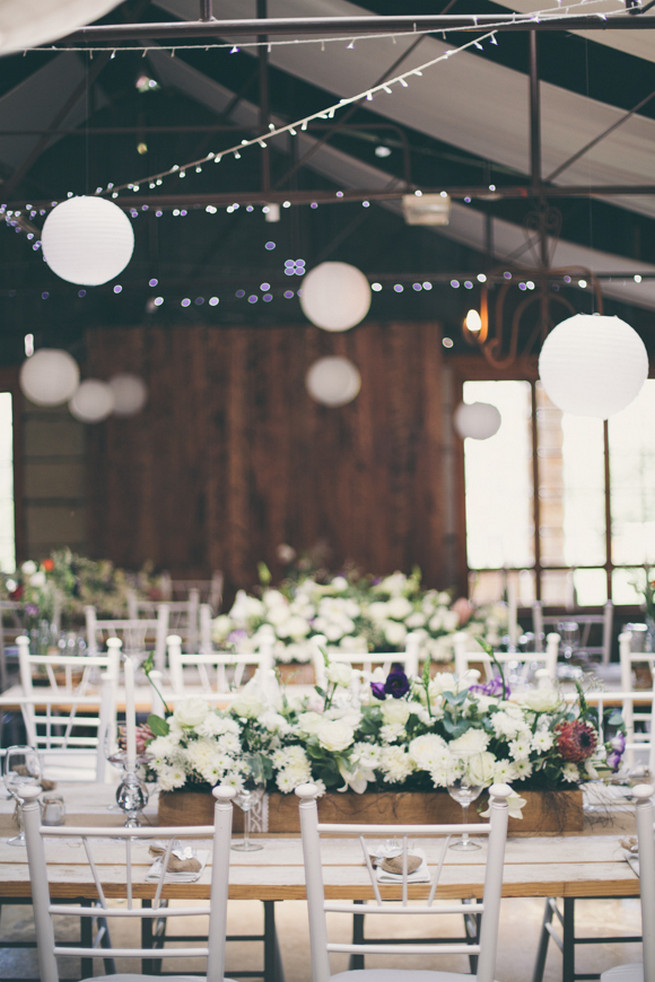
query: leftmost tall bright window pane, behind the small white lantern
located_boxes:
[464,381,534,569]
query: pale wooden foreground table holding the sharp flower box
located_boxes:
[0,783,639,980]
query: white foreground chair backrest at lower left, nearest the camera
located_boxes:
[21,787,234,982]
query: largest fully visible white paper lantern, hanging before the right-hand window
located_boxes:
[539,314,648,419]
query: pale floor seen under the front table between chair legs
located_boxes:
[0,899,641,982]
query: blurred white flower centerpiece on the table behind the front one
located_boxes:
[212,564,507,662]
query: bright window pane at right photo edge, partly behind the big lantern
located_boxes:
[608,379,655,565]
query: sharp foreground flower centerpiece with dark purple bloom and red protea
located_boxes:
[148,640,620,836]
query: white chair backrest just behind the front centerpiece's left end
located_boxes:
[167,634,273,701]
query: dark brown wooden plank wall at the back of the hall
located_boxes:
[86,323,453,589]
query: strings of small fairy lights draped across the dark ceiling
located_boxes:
[0,0,646,310]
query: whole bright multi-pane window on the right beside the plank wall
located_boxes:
[463,380,655,606]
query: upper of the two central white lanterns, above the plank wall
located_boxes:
[300,263,371,331]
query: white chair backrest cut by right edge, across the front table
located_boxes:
[619,631,655,773]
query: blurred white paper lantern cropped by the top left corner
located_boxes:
[0,0,118,55]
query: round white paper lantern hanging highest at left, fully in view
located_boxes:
[41,197,134,286]
